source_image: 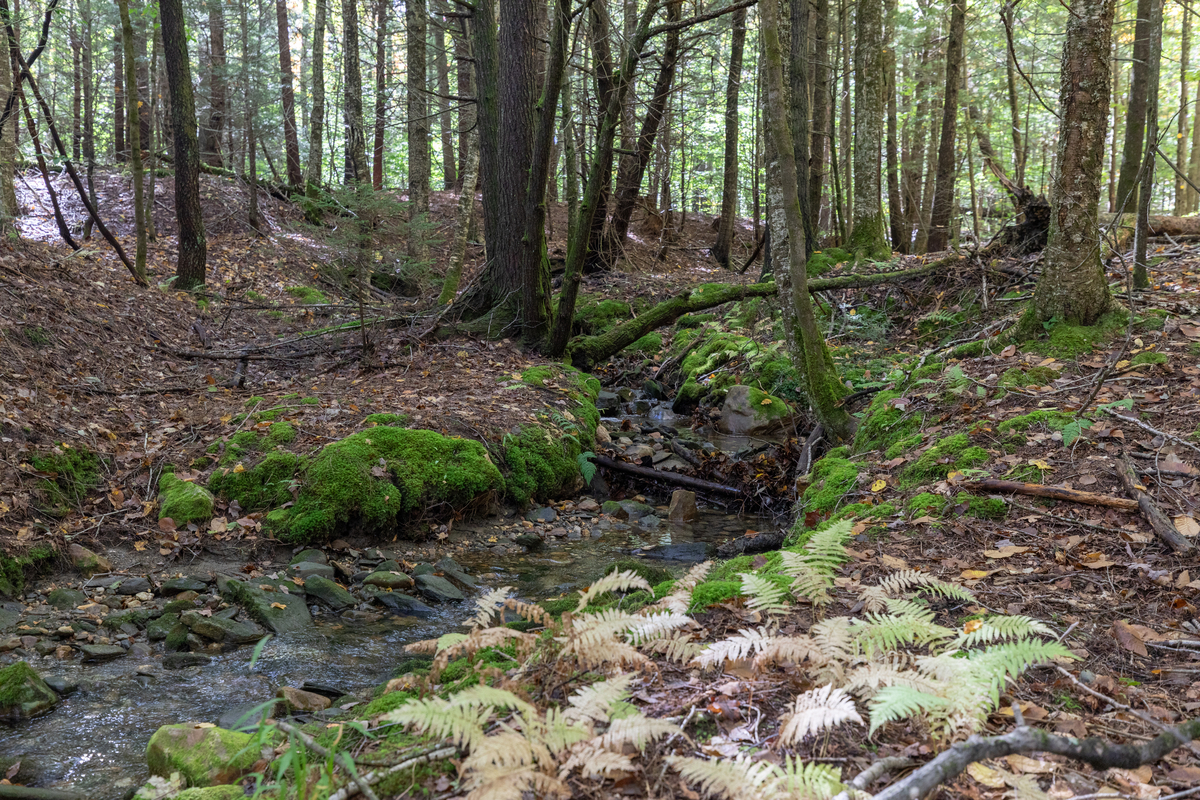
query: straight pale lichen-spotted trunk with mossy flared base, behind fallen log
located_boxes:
[847,0,892,260]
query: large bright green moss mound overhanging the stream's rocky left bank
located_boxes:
[268,426,504,542]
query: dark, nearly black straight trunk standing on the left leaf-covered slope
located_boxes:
[158,0,208,289]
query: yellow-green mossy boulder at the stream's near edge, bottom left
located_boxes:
[146,723,259,787]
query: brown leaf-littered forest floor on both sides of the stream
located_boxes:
[7,165,1200,800]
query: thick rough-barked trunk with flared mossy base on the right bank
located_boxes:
[1028,0,1114,325]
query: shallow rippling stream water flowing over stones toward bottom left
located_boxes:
[0,498,770,800]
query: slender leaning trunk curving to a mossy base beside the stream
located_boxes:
[758,0,854,443]
